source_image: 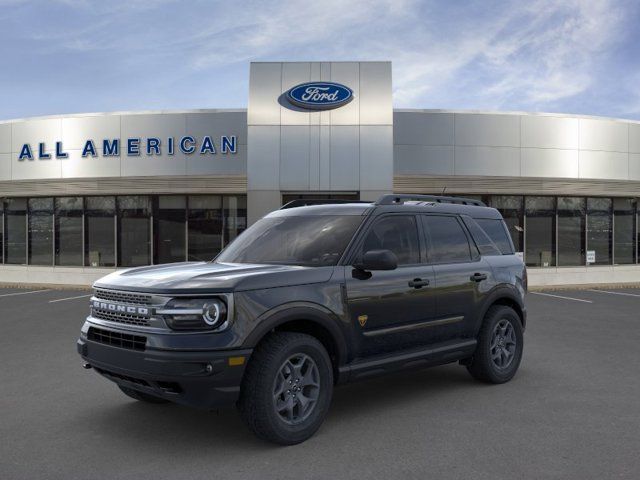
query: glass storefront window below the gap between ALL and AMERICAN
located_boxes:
[55,197,83,266]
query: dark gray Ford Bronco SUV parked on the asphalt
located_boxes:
[78,195,527,444]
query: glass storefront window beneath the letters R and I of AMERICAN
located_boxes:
[153,195,187,264]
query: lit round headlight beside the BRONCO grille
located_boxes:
[156,298,227,330]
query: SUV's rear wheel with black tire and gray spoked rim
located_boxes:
[467,305,524,383]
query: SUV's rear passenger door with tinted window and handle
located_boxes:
[422,215,492,340]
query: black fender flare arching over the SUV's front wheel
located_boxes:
[243,302,348,365]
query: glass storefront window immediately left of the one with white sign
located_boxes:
[558,197,586,267]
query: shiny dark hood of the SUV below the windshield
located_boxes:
[94,262,333,294]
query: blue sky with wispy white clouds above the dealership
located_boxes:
[0,0,640,119]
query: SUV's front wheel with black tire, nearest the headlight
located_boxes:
[239,332,333,445]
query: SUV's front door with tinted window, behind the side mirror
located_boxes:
[345,214,435,356]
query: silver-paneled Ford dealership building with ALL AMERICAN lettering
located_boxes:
[0,62,640,285]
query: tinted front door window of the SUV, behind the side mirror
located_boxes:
[362,215,420,265]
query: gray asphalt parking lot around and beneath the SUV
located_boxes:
[0,289,640,480]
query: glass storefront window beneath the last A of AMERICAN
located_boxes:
[189,195,222,261]
